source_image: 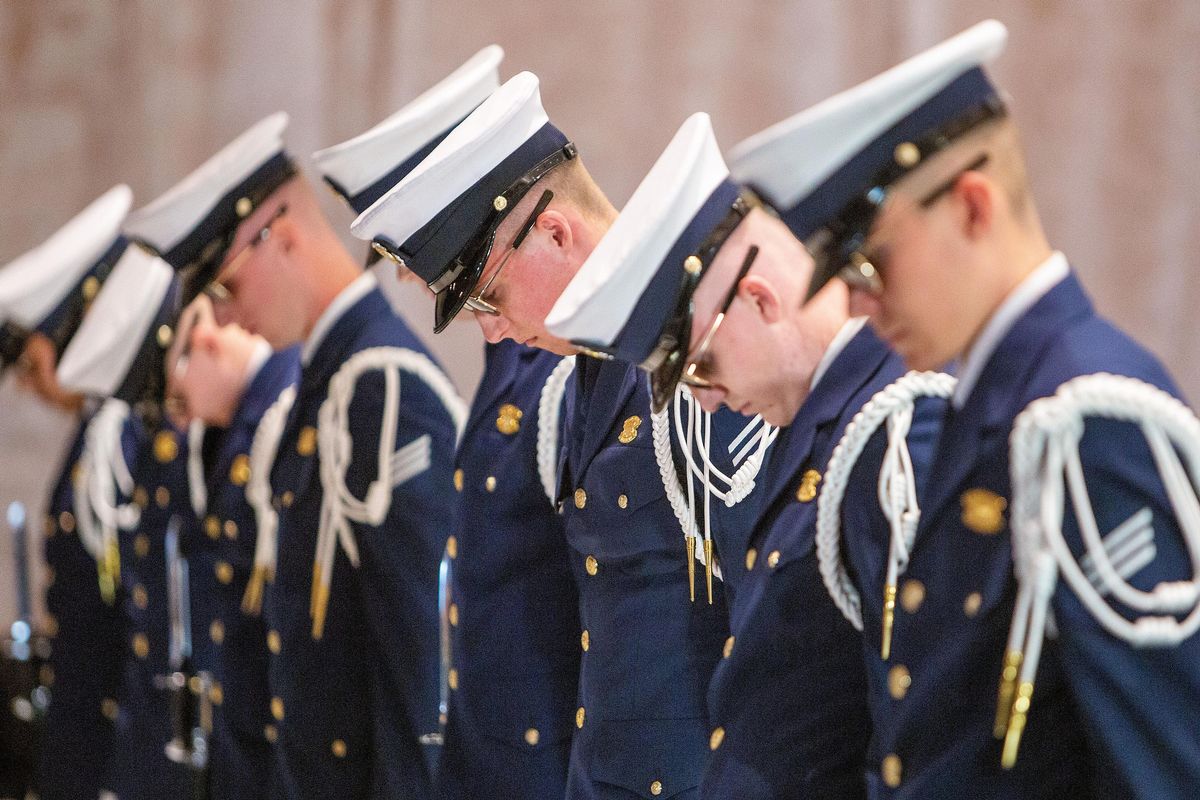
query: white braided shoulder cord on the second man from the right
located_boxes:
[816,372,956,661]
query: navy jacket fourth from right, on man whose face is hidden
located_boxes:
[438,341,580,800]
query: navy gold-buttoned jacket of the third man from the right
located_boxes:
[560,356,728,800]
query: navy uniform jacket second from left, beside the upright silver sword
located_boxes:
[113,415,211,800]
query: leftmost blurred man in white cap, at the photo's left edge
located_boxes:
[0,185,132,800]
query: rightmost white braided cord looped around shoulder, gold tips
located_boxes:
[994,373,1200,768]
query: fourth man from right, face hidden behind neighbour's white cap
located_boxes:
[313,44,580,800]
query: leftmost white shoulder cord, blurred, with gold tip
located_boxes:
[74,398,142,604]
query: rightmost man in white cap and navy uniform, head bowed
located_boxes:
[739,20,1200,798]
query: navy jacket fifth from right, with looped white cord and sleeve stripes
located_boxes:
[264,288,458,800]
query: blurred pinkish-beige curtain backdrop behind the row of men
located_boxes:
[0,0,1200,627]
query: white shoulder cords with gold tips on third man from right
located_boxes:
[650,386,779,603]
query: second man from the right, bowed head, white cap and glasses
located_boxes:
[546,114,936,799]
